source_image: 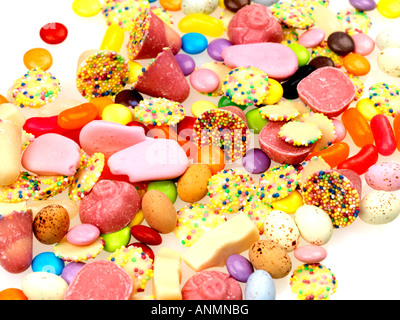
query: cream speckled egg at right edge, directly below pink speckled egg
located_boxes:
[359,190,400,224]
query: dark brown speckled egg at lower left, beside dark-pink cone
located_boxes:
[33,204,70,244]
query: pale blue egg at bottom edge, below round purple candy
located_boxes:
[244,269,276,300]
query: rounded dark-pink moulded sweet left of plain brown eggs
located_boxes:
[79,180,142,233]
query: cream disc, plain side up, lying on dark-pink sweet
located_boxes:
[279,121,322,147]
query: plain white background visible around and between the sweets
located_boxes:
[0,0,400,300]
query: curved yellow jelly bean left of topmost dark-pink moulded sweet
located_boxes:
[178,13,224,37]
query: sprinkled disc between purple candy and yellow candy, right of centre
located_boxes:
[256,164,298,204]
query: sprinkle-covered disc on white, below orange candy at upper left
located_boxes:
[7,68,61,108]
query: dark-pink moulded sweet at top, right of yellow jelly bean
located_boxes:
[227,3,284,44]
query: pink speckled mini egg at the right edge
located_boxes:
[365,162,400,191]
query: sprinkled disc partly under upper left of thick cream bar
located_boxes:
[174,203,226,247]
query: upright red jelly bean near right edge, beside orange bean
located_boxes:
[370,114,396,156]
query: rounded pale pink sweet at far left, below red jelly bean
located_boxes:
[21,133,81,176]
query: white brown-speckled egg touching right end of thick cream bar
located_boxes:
[264,210,300,252]
